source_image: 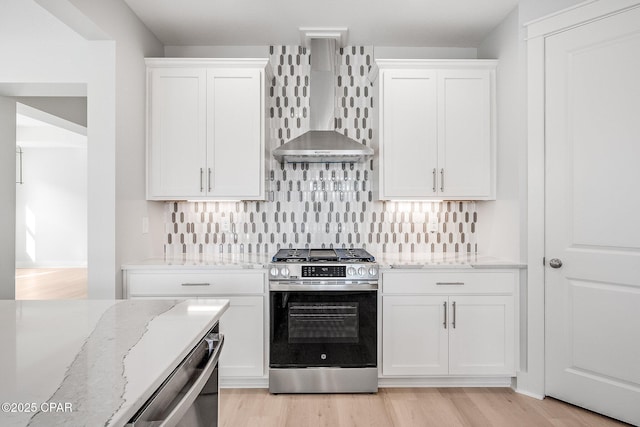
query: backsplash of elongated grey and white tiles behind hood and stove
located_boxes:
[165,46,478,256]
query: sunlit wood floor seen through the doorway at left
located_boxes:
[16,268,87,300]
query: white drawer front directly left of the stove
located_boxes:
[127,271,265,297]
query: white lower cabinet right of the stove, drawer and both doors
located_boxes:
[382,271,518,377]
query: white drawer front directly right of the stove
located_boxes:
[382,270,517,295]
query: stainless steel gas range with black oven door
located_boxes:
[269,249,378,393]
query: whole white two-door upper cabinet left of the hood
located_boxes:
[147,59,267,200]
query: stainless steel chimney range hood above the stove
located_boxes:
[273,38,373,163]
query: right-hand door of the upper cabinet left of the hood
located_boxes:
[207,69,264,200]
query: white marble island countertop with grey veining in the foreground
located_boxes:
[0,299,229,426]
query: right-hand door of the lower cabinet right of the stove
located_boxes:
[449,296,515,376]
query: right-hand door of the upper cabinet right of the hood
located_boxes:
[437,70,492,199]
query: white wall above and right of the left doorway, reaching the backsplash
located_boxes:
[0,0,163,298]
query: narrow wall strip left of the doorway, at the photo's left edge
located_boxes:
[0,97,16,299]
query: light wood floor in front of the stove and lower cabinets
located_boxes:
[220,388,627,427]
